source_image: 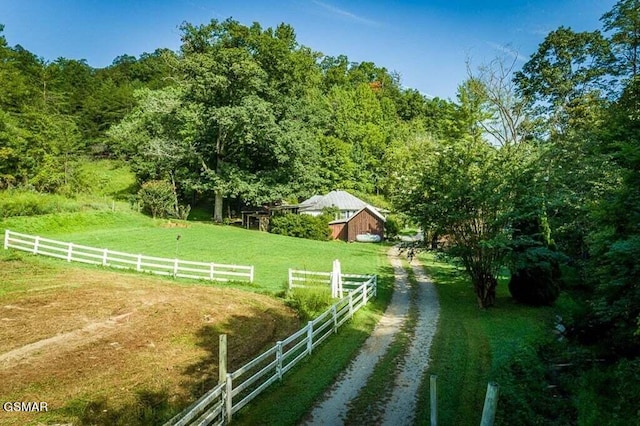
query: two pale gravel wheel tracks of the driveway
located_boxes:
[304,247,439,425]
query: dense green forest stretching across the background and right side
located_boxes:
[0,0,640,424]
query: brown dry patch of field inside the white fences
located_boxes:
[0,261,299,424]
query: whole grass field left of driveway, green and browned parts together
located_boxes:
[0,211,392,425]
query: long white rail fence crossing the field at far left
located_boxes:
[4,229,253,282]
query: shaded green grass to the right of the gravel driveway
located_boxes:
[417,254,553,426]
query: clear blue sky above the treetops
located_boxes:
[0,0,616,100]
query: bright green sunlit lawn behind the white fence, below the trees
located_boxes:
[0,211,384,293]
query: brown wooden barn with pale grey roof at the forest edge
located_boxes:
[299,191,386,241]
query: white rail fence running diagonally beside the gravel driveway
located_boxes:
[165,275,377,426]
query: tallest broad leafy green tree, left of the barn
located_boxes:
[111,20,317,221]
